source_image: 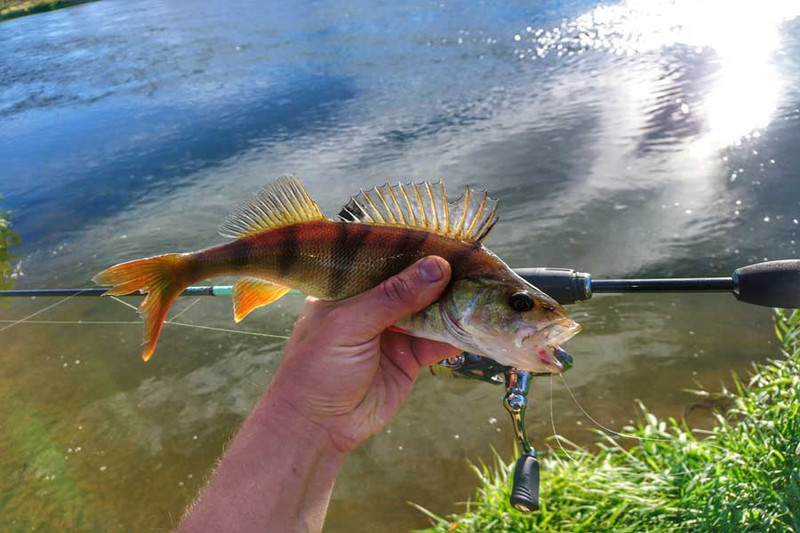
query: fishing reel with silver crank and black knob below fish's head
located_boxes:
[439,348,572,513]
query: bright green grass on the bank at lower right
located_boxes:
[417,311,800,533]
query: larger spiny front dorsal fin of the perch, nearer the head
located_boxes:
[339,181,497,242]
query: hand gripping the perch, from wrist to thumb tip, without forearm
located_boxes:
[267,256,460,452]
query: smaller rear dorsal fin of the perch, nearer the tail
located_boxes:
[219,177,327,239]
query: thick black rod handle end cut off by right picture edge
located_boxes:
[733,259,800,309]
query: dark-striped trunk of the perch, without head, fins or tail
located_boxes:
[188,220,505,300]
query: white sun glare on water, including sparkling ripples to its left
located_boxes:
[522,0,800,148]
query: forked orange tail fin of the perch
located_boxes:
[92,254,191,361]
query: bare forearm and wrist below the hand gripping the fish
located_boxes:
[181,378,346,532]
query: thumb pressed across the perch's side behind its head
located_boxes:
[334,255,450,338]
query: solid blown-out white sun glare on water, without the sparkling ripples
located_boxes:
[608,0,800,147]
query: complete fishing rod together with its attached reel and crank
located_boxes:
[0,259,800,512]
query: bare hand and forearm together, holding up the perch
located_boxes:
[179,257,460,532]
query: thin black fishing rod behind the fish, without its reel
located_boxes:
[0,259,800,308]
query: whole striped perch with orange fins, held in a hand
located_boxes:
[93,176,580,373]
